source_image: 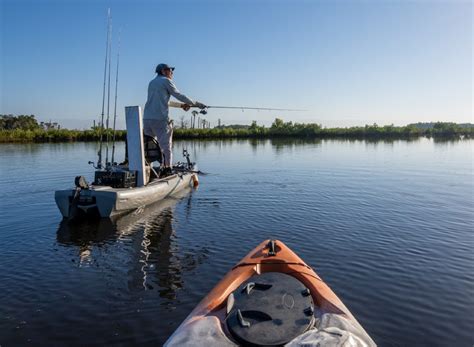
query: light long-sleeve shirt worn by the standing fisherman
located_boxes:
[143,75,194,122]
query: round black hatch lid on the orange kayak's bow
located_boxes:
[227,272,314,346]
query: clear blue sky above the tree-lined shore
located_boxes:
[0,0,473,128]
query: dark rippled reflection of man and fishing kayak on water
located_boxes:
[57,189,200,301]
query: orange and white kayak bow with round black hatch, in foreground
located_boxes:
[165,240,375,347]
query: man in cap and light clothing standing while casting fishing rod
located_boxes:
[143,64,206,176]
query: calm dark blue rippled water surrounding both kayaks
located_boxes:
[0,139,474,347]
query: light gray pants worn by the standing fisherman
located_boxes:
[143,119,173,167]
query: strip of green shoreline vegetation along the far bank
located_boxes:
[0,115,474,143]
